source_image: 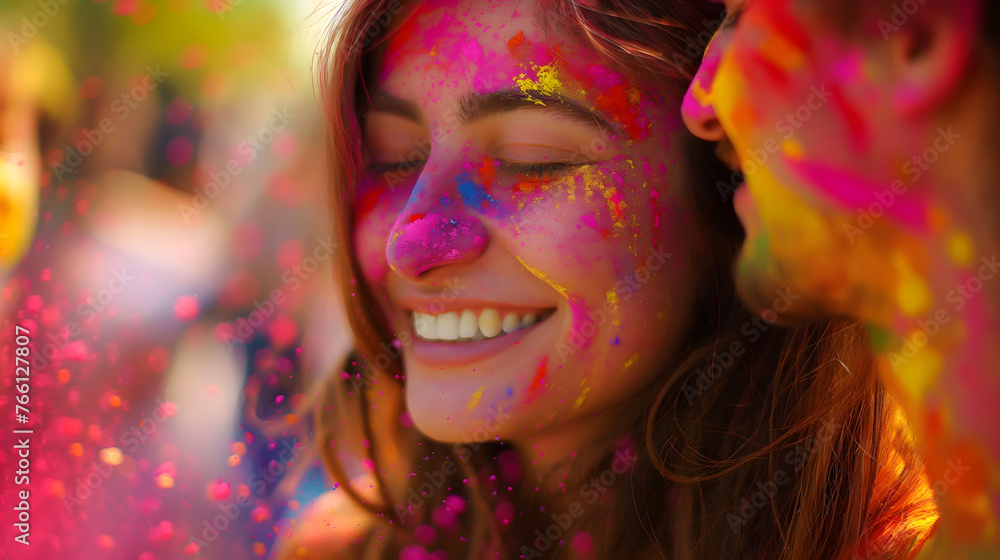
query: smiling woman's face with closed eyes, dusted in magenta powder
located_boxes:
[354,0,700,451]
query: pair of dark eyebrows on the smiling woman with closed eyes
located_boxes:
[371,90,622,138]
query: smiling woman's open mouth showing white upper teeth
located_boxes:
[410,307,555,342]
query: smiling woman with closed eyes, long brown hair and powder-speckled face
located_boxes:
[282,0,934,559]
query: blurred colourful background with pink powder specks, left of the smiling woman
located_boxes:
[0,0,349,560]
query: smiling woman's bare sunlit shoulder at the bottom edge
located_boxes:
[275,475,376,560]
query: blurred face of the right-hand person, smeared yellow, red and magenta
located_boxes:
[683,0,958,318]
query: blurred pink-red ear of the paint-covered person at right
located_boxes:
[879,0,980,117]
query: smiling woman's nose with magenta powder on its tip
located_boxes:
[385,171,490,281]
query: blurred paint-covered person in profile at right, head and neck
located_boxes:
[684,0,1000,558]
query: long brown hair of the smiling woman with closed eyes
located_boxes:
[317,0,936,560]
